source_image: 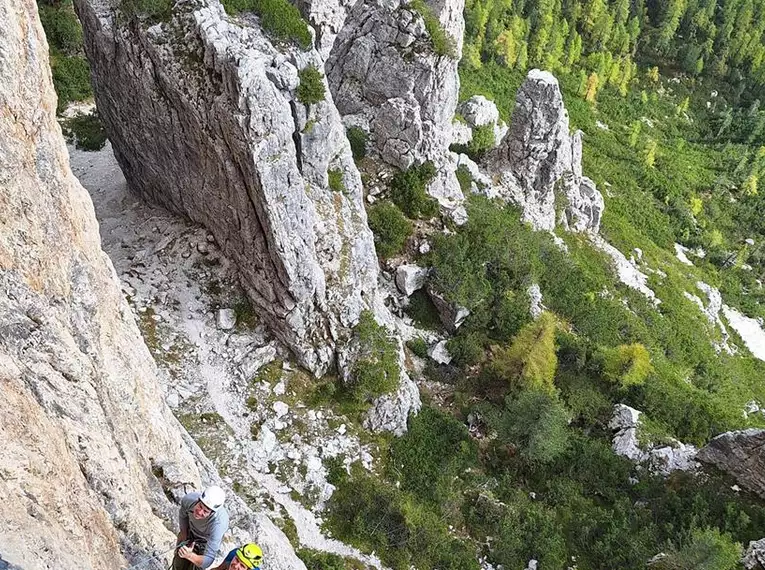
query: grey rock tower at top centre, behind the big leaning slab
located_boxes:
[326,0,464,217]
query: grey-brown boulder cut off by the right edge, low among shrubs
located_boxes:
[698,429,765,497]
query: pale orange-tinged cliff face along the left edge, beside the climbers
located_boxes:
[0,0,200,570]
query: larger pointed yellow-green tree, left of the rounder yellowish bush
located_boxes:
[492,312,558,394]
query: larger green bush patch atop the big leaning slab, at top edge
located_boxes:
[222,0,308,47]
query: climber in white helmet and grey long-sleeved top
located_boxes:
[173,485,228,570]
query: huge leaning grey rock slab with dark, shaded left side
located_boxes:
[76,0,377,374]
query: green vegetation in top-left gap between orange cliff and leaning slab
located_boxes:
[37,0,93,113]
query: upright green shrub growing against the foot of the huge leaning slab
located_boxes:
[349,311,401,403]
